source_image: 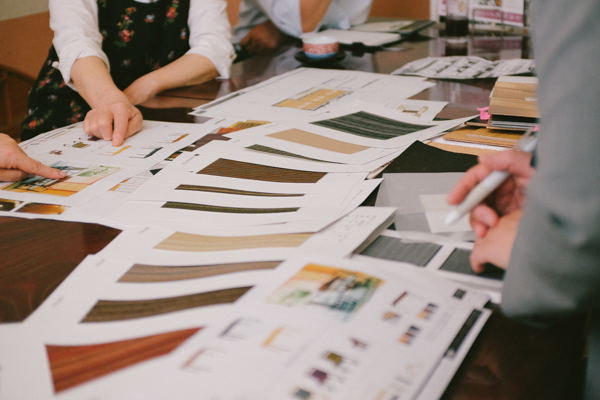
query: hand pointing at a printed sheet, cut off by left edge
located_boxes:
[0,133,67,181]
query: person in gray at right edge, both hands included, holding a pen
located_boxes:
[448,0,600,399]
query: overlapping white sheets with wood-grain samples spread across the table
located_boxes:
[0,68,496,399]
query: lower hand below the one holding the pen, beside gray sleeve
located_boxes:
[470,209,523,273]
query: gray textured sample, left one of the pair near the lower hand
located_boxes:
[361,236,442,267]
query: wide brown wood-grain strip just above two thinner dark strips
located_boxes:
[197,158,326,183]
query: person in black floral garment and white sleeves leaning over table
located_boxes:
[21,0,235,146]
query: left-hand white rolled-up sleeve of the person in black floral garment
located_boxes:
[49,0,110,89]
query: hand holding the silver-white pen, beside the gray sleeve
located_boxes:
[447,150,535,238]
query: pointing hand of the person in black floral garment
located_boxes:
[83,100,143,147]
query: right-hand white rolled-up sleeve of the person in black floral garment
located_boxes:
[187,0,235,78]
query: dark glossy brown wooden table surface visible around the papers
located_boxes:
[0,28,585,400]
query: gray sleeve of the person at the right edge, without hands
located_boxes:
[502,0,600,325]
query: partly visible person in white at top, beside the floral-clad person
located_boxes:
[233,0,371,54]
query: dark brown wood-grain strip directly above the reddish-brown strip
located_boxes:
[81,286,252,322]
